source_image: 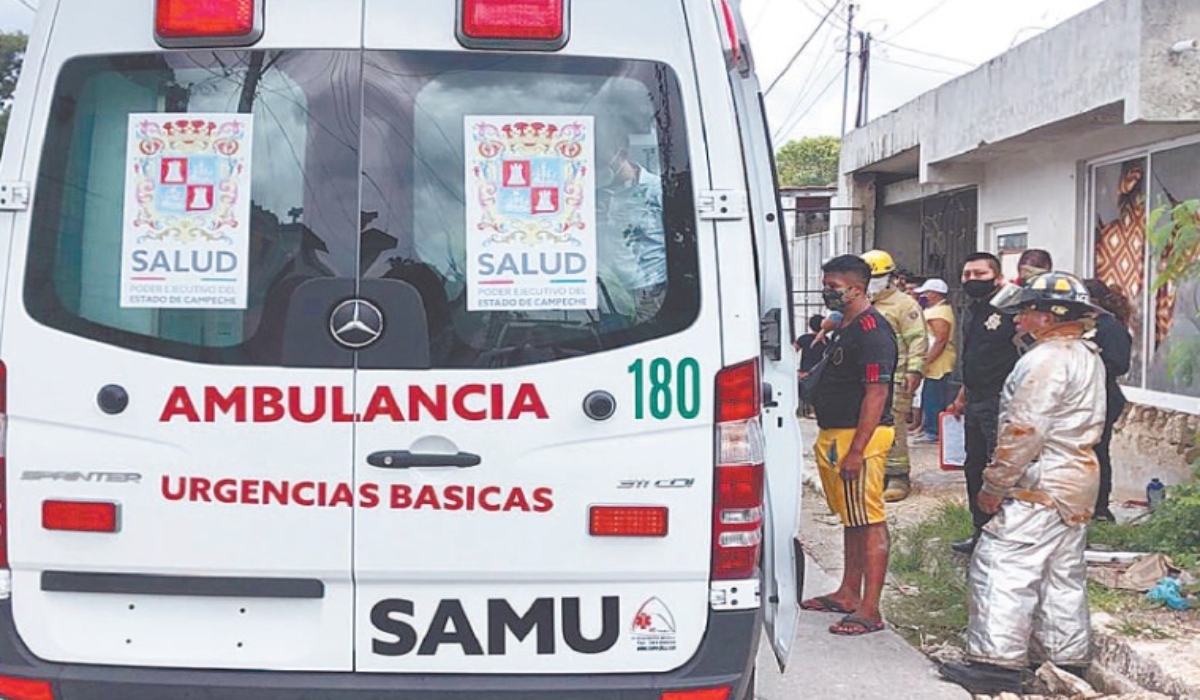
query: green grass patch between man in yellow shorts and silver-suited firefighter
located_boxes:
[886,503,971,646]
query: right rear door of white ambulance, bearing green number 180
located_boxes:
[354,0,724,674]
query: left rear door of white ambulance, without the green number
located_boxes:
[0,0,361,671]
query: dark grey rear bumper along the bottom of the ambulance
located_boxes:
[0,602,762,700]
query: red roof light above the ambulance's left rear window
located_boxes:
[155,0,263,48]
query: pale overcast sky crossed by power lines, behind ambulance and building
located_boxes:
[0,0,1100,144]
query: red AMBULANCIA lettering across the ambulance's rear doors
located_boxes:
[158,383,550,423]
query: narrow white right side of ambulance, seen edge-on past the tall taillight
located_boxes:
[689,0,804,668]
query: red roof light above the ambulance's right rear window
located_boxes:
[456,0,570,50]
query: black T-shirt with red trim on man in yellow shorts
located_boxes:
[812,306,896,429]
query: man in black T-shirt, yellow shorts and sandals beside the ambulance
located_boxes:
[800,256,896,635]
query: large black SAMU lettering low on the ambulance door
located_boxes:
[371,596,620,657]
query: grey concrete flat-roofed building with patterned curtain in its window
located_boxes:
[839,0,1200,498]
